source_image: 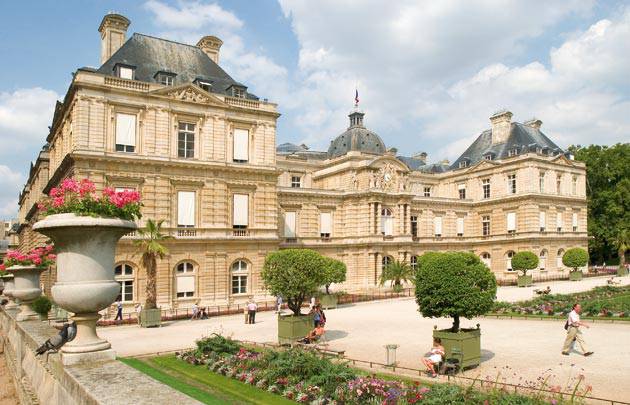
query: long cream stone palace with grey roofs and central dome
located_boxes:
[14,14,587,308]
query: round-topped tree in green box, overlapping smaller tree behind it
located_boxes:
[261,249,327,316]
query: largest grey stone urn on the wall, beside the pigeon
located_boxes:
[33,214,137,365]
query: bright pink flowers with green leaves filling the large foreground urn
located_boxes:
[38,178,142,221]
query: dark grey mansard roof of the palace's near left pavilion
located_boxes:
[97,33,258,99]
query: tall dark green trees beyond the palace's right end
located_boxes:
[569,143,630,263]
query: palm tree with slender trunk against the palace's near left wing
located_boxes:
[134,219,173,309]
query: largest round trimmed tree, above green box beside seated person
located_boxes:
[416,252,497,333]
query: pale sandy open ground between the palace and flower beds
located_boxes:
[99,277,630,401]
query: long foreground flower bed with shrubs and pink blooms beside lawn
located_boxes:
[177,334,592,405]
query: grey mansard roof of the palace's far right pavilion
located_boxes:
[450,122,564,170]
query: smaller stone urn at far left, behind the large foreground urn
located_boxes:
[7,266,46,322]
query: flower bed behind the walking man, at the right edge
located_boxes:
[492,286,630,317]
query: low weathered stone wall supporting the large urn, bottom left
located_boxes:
[0,308,200,405]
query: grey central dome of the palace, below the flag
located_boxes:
[328,111,386,158]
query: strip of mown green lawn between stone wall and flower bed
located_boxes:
[121,355,295,405]
